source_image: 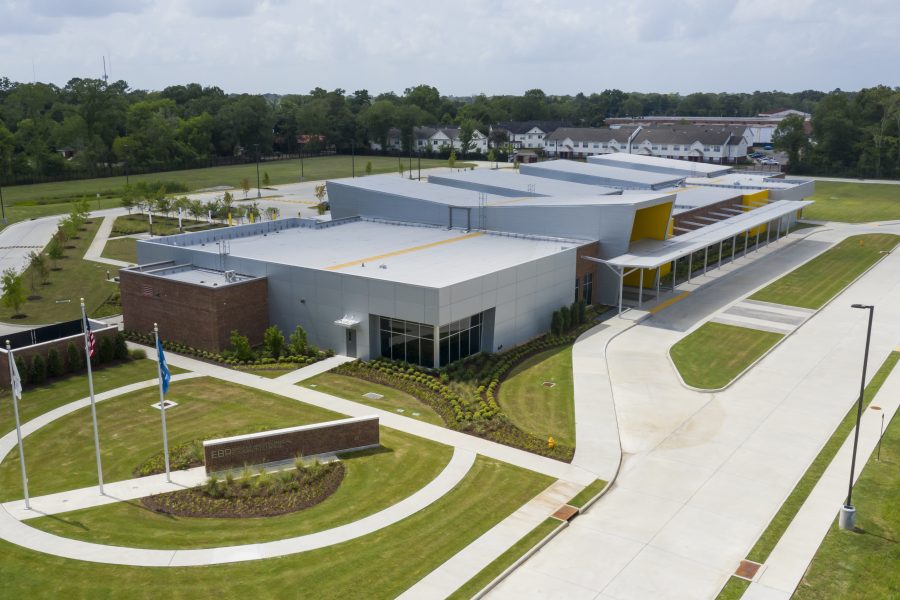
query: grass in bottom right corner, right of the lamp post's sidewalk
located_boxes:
[793,386,900,600]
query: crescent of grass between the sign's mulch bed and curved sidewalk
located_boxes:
[26,428,453,549]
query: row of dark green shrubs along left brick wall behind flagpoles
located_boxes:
[15,333,132,385]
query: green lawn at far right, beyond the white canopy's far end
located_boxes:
[803,181,900,223]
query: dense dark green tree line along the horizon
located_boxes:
[0,77,900,178]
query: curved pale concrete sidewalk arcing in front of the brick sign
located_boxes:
[0,448,476,567]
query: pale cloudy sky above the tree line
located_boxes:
[0,0,900,95]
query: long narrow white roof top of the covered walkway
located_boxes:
[606,200,813,269]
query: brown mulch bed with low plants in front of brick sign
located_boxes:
[141,462,344,519]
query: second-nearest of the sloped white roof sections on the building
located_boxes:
[428,169,622,196]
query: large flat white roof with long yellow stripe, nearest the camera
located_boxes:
[158,218,589,288]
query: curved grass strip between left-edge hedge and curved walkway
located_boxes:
[0,360,178,435]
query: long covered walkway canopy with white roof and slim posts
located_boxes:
[586,200,812,312]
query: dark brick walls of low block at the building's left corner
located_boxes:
[119,269,269,352]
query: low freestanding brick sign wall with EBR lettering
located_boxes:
[203,417,380,473]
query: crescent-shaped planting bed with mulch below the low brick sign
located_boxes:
[141,460,344,519]
